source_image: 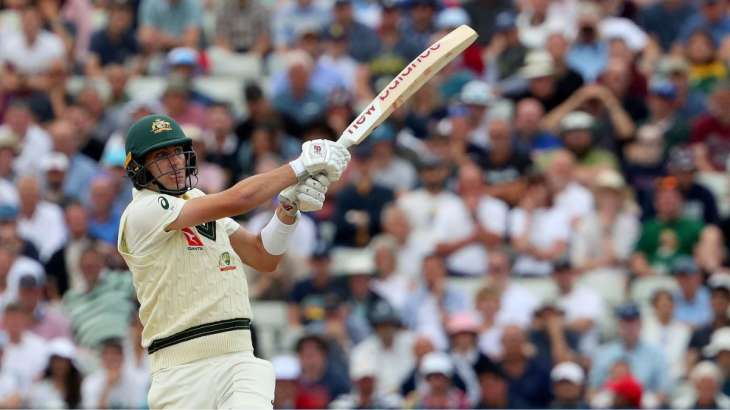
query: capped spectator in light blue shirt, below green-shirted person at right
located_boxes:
[671,257,712,329]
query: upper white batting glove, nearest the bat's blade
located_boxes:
[289,139,350,181]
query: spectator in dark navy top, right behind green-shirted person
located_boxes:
[667,148,720,225]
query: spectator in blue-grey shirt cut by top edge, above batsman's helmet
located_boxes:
[137,0,203,53]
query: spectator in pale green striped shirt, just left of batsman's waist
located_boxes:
[63,245,134,348]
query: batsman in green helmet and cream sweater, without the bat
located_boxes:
[118,115,350,409]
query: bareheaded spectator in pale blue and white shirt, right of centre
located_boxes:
[402,254,467,350]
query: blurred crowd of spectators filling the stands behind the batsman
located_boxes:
[0,0,730,409]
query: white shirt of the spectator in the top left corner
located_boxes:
[0,30,65,74]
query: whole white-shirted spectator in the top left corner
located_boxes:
[0,4,65,75]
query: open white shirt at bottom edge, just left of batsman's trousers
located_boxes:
[81,368,148,409]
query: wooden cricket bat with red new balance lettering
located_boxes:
[337,25,477,147]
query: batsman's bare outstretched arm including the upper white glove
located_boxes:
[165,140,350,231]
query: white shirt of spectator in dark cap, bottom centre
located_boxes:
[350,330,416,395]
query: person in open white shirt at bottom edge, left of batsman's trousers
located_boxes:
[81,339,147,409]
